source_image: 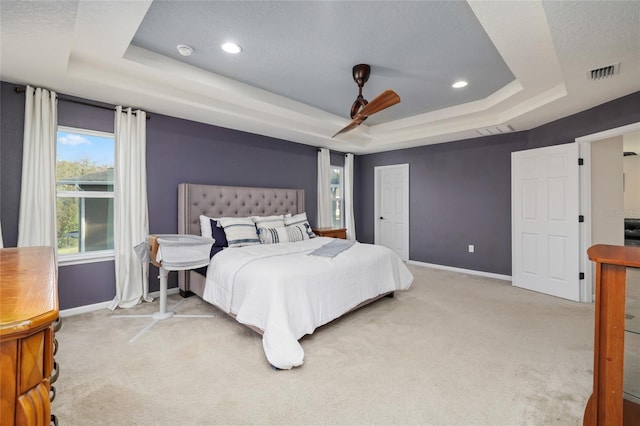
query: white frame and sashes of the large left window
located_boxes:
[56,126,116,266]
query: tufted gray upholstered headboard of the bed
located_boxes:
[178,183,305,296]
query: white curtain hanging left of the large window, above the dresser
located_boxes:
[18,86,58,255]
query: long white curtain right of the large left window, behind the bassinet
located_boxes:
[109,106,150,309]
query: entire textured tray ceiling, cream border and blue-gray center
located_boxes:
[0,0,640,153]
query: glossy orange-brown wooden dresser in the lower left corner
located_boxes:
[0,247,58,426]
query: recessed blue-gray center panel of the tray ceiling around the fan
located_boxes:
[132,1,514,124]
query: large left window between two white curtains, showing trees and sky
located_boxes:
[56,126,115,264]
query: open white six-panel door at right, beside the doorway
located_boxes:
[511,143,580,301]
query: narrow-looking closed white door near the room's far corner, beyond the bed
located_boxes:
[374,164,409,261]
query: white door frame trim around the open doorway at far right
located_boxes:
[575,122,640,303]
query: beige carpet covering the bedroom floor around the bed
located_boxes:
[52,266,594,426]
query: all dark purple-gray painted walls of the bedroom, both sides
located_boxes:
[0,78,640,309]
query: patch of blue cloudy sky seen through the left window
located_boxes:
[56,131,115,167]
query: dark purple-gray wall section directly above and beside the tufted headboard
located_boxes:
[147,108,317,238]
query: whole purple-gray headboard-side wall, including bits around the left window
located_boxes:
[0,82,320,309]
